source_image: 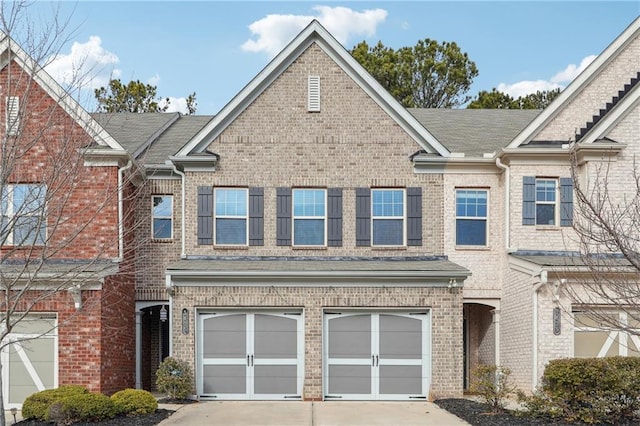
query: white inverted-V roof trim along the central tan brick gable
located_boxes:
[174,20,449,160]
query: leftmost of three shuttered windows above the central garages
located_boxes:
[214,188,248,245]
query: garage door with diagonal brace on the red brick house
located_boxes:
[0,315,58,408]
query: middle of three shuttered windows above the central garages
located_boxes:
[293,189,327,246]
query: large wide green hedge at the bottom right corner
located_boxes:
[520,357,640,424]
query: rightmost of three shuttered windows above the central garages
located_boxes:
[371,189,404,246]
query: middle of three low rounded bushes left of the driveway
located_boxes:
[49,393,117,425]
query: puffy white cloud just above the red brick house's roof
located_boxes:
[45,36,121,89]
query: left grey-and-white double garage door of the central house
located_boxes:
[197,311,304,400]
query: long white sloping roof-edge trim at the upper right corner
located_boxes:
[507,17,640,148]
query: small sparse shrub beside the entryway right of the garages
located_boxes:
[471,365,515,413]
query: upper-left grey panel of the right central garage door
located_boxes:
[329,314,371,359]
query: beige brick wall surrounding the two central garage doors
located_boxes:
[172,283,463,400]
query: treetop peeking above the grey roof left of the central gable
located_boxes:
[94,79,198,115]
